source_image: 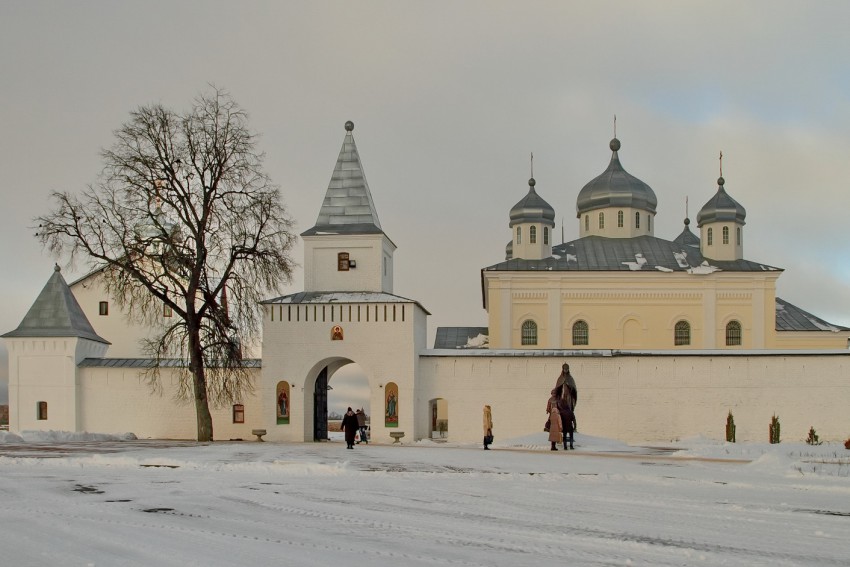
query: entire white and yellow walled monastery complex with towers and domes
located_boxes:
[3,122,850,443]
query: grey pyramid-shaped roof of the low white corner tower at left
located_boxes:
[3,265,110,344]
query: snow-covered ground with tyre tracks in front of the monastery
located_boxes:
[0,432,850,567]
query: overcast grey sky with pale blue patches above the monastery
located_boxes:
[0,0,850,400]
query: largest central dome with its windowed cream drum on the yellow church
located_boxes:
[576,138,658,238]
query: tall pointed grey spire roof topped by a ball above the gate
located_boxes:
[301,121,383,236]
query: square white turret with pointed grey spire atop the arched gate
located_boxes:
[301,120,396,293]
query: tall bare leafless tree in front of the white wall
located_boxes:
[35,88,295,441]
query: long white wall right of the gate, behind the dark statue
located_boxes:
[417,351,850,443]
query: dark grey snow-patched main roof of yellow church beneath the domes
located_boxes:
[484,235,782,273]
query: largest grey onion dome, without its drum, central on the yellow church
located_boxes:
[576,138,658,217]
